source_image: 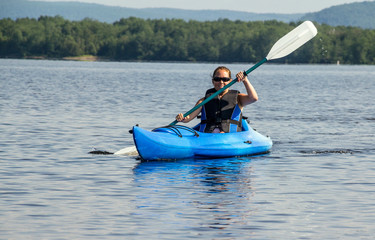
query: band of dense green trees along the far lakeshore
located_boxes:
[0,16,375,64]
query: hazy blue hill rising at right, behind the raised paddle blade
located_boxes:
[303,1,375,29]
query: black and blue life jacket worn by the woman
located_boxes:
[199,88,242,132]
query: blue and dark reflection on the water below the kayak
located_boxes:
[133,158,266,230]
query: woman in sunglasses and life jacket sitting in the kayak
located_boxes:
[176,66,258,133]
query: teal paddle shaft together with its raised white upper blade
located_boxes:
[169,21,318,126]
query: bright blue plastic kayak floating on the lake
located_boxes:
[133,120,272,160]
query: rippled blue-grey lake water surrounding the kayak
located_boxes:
[0,59,375,239]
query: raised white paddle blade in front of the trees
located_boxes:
[266,21,318,60]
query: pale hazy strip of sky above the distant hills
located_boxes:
[33,0,372,13]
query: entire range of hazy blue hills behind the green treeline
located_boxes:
[0,0,375,29]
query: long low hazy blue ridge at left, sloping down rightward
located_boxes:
[0,0,303,23]
